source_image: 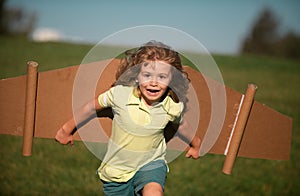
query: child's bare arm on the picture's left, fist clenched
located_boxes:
[55,98,102,145]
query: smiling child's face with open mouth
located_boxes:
[138,61,172,105]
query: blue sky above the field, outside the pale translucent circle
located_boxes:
[7,0,300,54]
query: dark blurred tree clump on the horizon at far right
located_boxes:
[241,8,300,58]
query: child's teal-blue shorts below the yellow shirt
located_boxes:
[102,160,168,196]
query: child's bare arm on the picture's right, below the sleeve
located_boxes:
[177,118,201,159]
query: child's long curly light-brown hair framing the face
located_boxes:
[114,41,190,110]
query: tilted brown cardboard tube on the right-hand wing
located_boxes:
[223,84,257,175]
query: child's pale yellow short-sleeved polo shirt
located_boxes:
[98,85,183,182]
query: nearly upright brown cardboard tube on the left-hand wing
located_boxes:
[23,61,38,156]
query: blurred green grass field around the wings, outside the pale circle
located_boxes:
[0,37,300,196]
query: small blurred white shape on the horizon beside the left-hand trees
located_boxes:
[32,28,64,42]
